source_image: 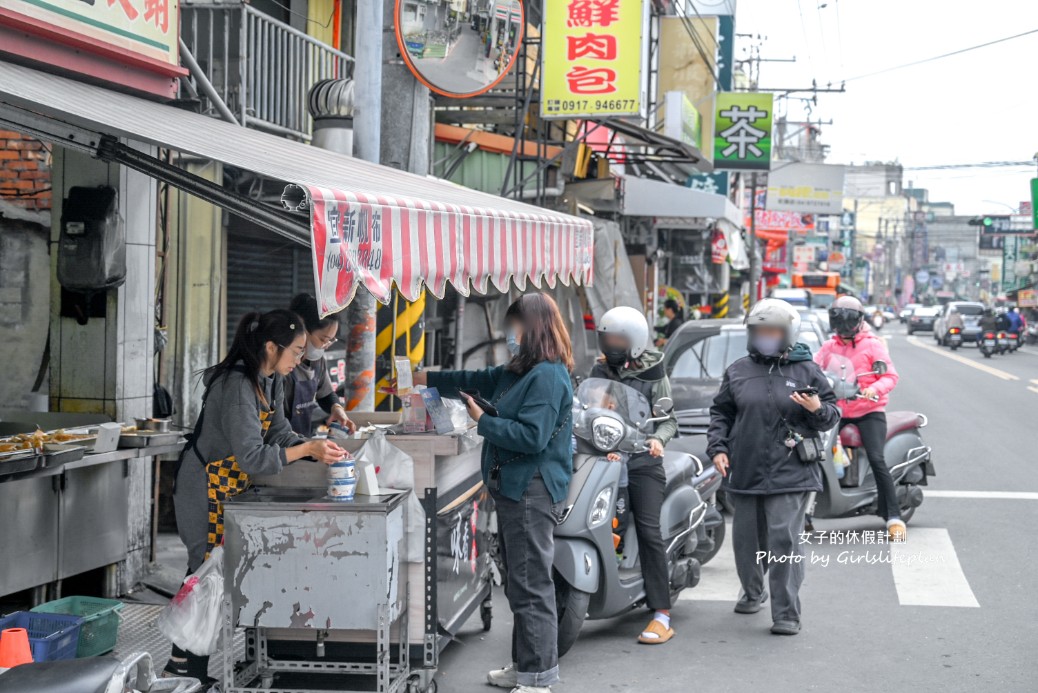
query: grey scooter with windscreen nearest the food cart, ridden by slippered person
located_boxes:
[554,378,723,656]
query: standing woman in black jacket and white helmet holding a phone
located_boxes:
[707,299,840,635]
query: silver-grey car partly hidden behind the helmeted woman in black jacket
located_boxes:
[663,320,828,436]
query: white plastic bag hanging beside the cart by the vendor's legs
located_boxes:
[159,547,223,656]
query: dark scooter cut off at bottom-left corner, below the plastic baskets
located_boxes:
[0,653,202,693]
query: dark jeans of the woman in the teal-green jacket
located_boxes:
[493,476,558,686]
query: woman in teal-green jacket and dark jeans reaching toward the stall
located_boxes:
[415,294,573,693]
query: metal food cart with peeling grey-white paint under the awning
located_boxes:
[223,414,493,693]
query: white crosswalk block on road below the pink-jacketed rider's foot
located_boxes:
[890,527,980,607]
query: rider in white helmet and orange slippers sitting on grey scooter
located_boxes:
[591,306,678,645]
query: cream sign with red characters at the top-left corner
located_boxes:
[0,0,180,65]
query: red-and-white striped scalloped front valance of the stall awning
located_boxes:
[298,187,594,313]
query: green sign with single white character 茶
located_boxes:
[714,91,774,171]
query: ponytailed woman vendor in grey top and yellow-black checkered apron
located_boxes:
[165,310,346,682]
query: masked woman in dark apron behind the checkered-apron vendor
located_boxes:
[284,294,357,436]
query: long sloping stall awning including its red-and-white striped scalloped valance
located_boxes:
[0,61,594,313]
